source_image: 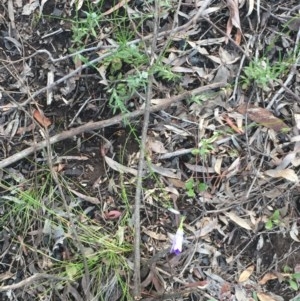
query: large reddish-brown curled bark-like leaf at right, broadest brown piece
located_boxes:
[237,103,290,133]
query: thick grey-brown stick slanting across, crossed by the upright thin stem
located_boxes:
[0,82,227,169]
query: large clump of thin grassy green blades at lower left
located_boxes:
[1,170,133,300]
